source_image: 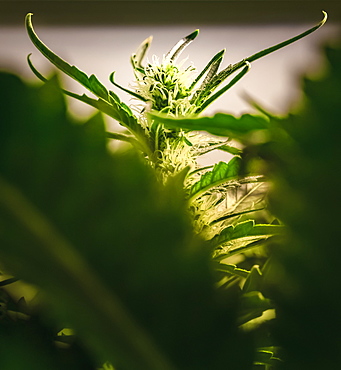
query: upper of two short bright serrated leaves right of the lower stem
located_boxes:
[189,157,241,201]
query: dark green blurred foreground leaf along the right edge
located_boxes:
[254,42,341,370]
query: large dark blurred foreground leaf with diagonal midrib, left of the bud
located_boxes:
[0,73,254,370]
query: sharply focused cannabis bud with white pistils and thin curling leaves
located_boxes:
[26,13,327,246]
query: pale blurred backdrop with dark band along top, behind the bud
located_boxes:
[0,0,341,163]
